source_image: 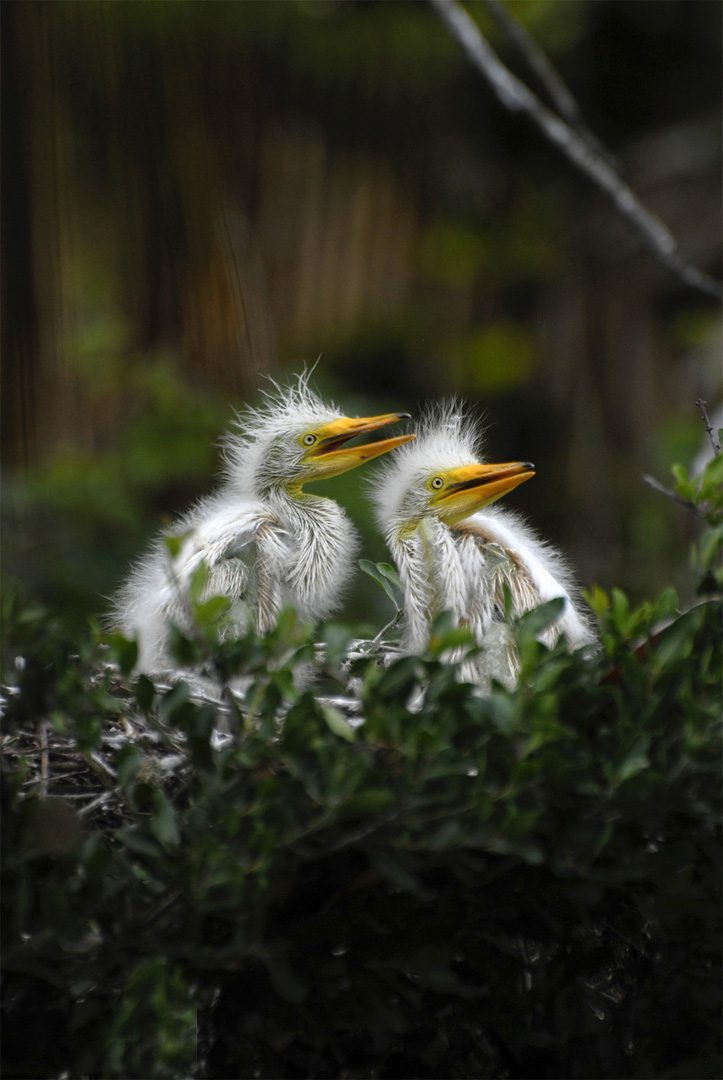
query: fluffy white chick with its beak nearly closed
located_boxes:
[372,402,595,686]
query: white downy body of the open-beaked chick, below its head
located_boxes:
[112,494,357,671]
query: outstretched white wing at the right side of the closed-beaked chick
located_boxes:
[457,510,594,647]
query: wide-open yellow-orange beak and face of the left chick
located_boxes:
[304,413,416,482]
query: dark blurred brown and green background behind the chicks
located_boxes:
[1,0,721,621]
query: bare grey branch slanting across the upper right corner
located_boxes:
[429,0,723,299]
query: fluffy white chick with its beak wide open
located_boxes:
[115,372,415,673]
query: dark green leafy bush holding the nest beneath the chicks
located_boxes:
[2,459,723,1078]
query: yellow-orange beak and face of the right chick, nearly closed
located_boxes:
[429,461,535,524]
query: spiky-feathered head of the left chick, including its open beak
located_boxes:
[225,375,416,496]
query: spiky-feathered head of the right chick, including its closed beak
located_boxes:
[373,403,535,531]
